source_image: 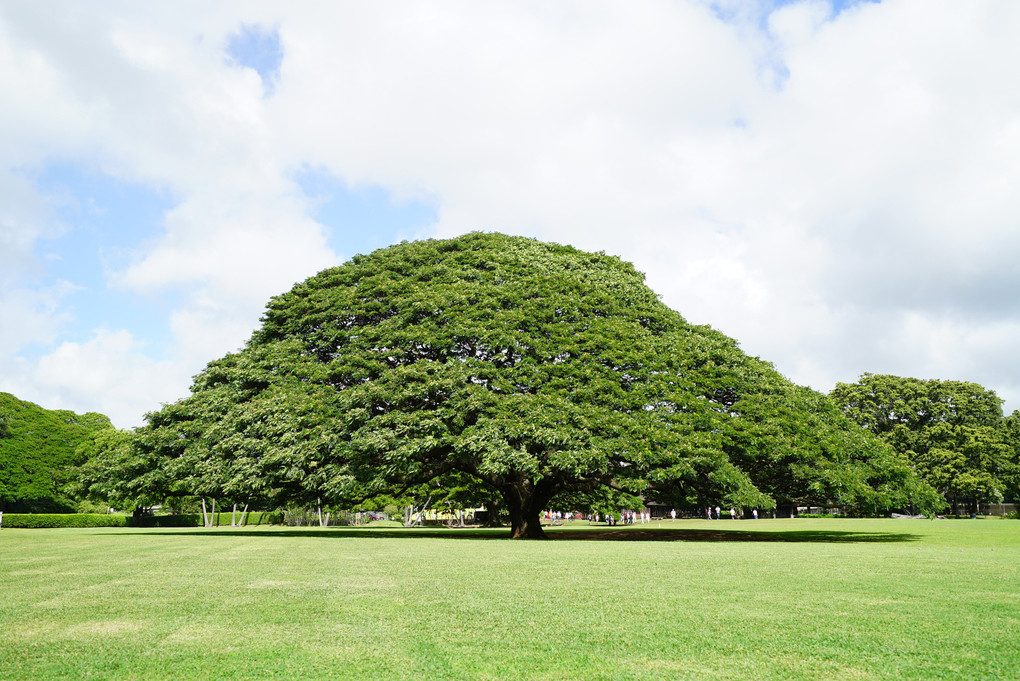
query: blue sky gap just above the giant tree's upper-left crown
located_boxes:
[293,167,439,258]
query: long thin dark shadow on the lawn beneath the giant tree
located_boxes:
[125,527,921,543]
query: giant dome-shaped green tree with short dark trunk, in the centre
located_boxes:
[131,233,930,537]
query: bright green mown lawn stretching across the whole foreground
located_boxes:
[0,519,1020,681]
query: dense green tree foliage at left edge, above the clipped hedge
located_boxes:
[0,392,113,513]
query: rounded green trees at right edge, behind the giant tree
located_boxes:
[830,374,1020,513]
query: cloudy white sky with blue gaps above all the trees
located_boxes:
[0,0,1020,428]
